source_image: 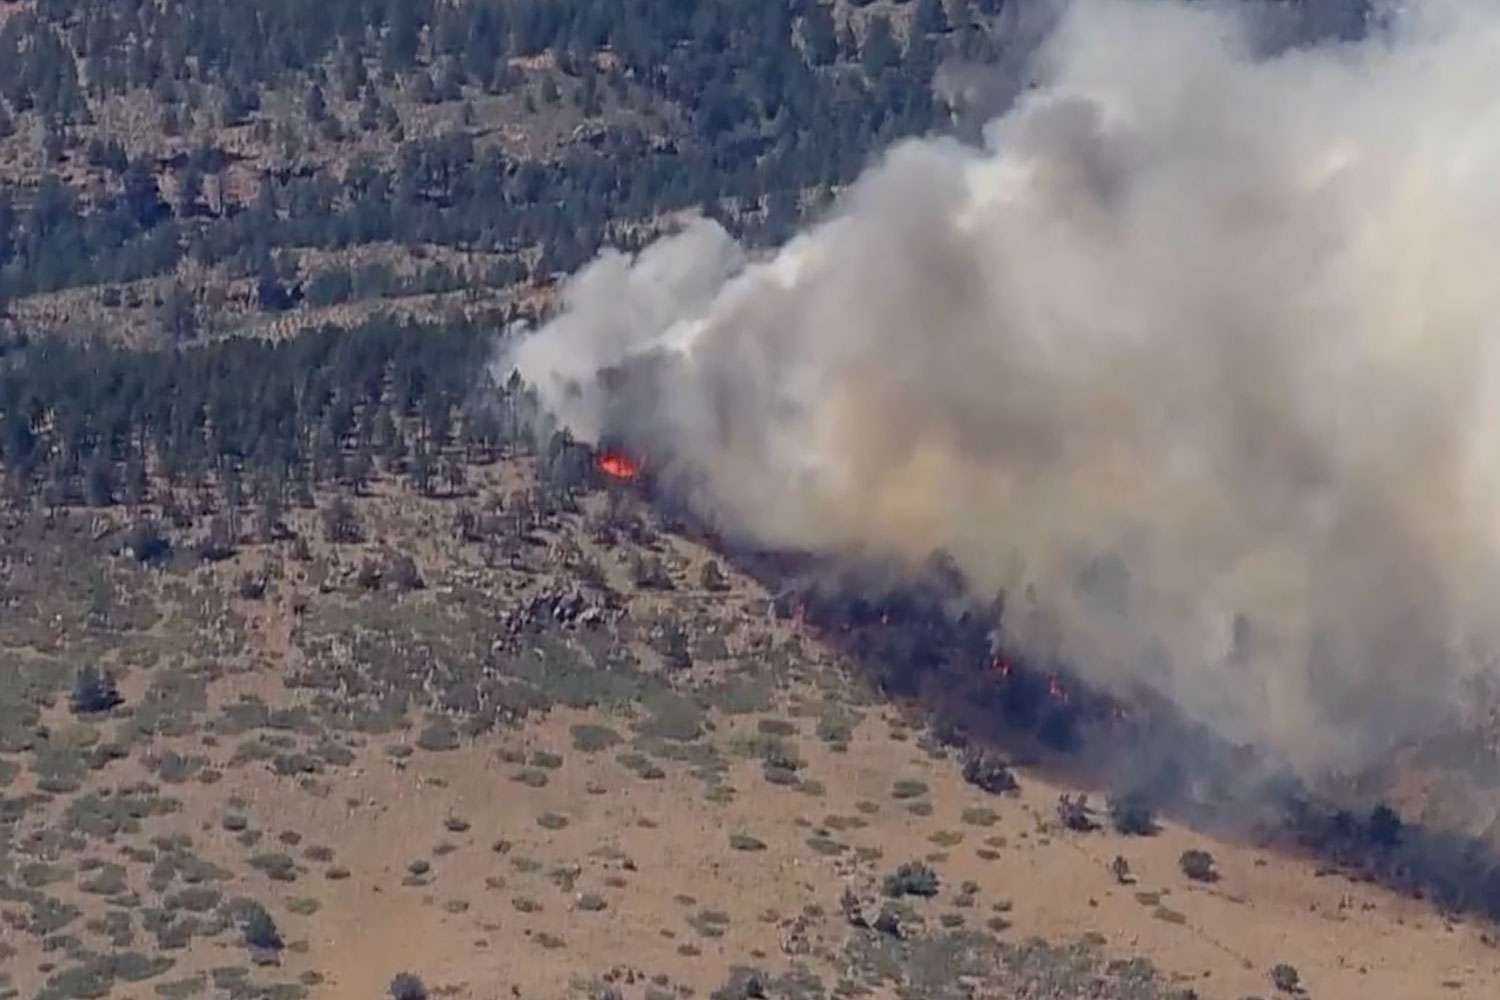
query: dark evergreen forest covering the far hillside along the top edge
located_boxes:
[0,0,1001,307]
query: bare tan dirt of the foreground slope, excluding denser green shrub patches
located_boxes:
[0,469,1500,1000]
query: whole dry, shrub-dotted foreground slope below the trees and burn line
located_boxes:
[0,462,1500,999]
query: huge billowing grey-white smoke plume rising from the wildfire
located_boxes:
[498,0,1500,769]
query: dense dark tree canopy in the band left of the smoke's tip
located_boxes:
[0,319,504,512]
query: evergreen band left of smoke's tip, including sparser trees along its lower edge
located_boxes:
[0,319,591,535]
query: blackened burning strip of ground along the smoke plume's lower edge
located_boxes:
[714,539,1500,921]
